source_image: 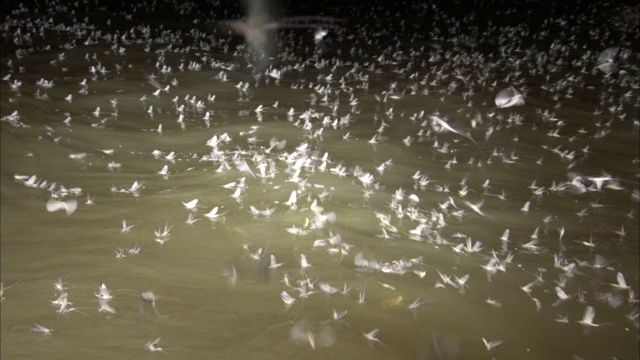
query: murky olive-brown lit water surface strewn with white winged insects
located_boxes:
[0,0,639,359]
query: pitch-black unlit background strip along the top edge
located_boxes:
[2,0,640,54]
